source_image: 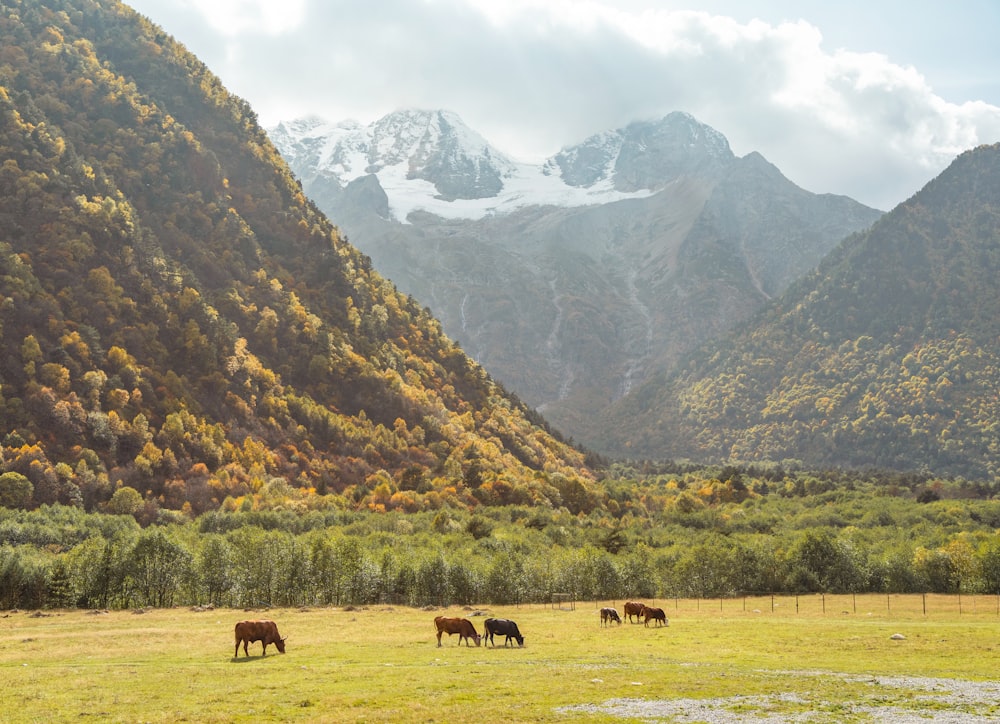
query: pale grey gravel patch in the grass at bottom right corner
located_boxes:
[557,671,1000,724]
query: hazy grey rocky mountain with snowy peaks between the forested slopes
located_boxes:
[269,110,882,452]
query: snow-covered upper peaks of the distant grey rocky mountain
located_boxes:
[271,109,734,221]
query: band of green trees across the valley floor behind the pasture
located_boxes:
[0,480,1000,609]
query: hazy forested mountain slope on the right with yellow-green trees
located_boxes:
[610,145,1000,476]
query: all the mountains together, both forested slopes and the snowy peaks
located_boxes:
[0,0,1000,504]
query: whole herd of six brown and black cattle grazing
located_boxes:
[233,601,670,658]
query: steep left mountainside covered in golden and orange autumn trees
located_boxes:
[0,0,590,518]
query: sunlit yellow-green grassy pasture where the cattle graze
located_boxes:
[0,596,1000,723]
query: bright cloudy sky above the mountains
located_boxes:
[125,0,1000,210]
